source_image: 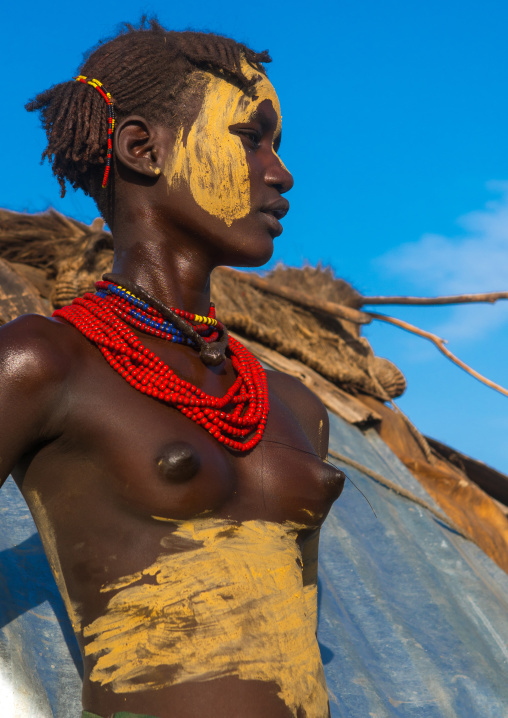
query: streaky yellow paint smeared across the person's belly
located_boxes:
[83,519,328,718]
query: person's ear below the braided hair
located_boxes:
[113,115,173,179]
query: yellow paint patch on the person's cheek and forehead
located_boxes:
[164,60,281,227]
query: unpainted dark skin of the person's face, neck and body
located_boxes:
[0,76,344,718]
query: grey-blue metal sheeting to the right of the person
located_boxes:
[318,416,508,718]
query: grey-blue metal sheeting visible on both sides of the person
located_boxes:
[0,408,508,718]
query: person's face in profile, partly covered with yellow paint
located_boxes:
[164,61,293,264]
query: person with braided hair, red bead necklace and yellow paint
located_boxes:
[0,16,343,718]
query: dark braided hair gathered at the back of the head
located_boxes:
[26,18,270,220]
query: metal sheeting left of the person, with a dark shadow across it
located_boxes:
[0,479,81,718]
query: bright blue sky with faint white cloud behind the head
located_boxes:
[0,0,508,473]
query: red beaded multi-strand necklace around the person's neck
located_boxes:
[53,282,269,451]
